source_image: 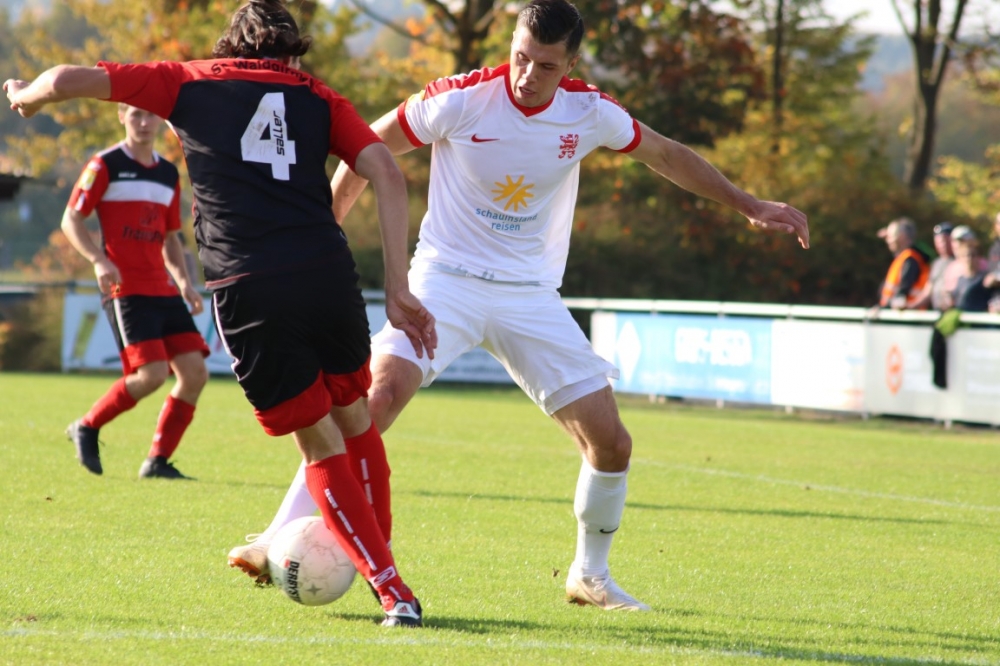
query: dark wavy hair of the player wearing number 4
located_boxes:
[212,0,312,59]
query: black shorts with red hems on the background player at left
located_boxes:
[104,295,209,375]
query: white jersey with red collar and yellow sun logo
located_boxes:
[398,65,641,288]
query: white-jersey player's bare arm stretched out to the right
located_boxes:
[629,123,809,248]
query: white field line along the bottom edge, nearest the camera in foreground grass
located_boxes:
[0,629,995,666]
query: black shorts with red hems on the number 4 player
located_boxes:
[214,253,371,435]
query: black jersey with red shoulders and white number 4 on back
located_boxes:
[99,59,379,287]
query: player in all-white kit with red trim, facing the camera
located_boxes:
[230,0,809,610]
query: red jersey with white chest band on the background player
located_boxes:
[69,143,181,298]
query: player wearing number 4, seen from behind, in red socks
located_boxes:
[4,0,437,626]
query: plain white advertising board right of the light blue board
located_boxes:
[771,319,865,412]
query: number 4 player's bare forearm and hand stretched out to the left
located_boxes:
[3,65,111,118]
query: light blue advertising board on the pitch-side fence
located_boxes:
[611,312,771,404]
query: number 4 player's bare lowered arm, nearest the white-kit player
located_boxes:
[355,143,437,358]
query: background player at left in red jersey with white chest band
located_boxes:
[62,104,209,479]
